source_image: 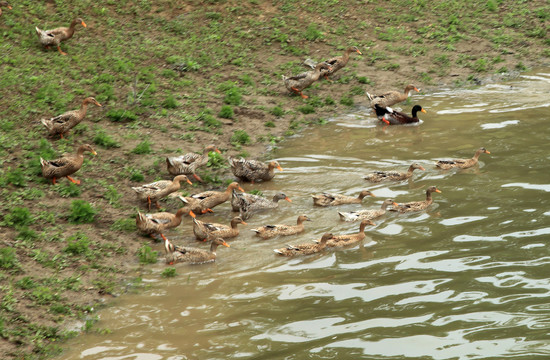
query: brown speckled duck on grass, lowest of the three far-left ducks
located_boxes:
[40,144,97,185]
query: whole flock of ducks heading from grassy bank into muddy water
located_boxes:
[28,15,496,264]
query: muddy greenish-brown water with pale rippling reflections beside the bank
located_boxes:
[60,69,550,360]
